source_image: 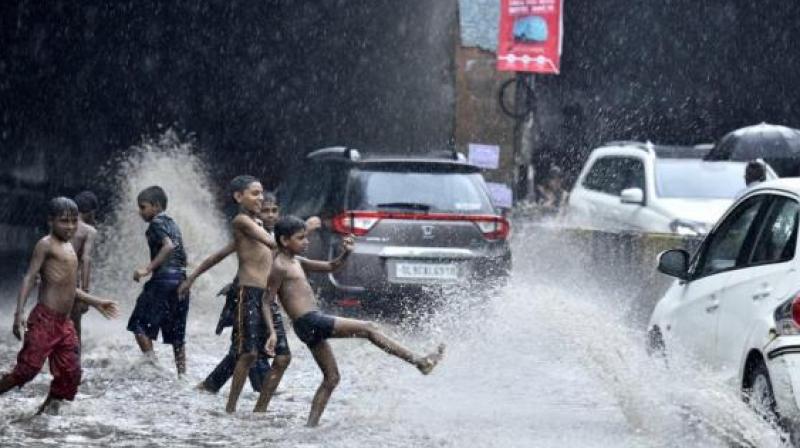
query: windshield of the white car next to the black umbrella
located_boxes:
[655,159,747,199]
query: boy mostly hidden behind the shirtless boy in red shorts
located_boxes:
[70,191,97,343]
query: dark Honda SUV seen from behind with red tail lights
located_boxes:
[278,147,511,306]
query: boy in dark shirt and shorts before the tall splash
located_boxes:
[128,186,189,376]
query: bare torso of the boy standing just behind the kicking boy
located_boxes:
[232,213,273,289]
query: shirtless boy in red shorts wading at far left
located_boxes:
[0,197,117,414]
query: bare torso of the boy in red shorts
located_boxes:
[31,235,78,314]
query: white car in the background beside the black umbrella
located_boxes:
[567,142,777,235]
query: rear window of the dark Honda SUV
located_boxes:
[348,170,494,214]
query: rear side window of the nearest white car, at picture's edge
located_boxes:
[752,197,800,264]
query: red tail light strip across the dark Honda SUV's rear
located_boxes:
[332,211,511,240]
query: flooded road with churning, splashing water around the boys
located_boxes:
[0,142,781,447]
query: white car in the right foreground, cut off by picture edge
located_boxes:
[648,178,800,427]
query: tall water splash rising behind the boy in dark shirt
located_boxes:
[94,130,235,320]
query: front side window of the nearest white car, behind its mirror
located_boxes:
[695,195,764,277]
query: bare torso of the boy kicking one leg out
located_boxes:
[270,252,319,320]
